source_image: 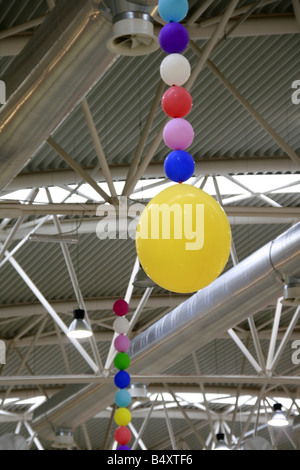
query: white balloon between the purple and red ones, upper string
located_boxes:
[160,54,191,86]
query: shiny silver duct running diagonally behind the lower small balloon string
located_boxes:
[33,223,300,437]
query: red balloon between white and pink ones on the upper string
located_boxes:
[161,85,193,118]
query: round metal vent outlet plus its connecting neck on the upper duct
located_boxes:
[100,0,159,56]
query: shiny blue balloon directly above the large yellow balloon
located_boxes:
[164,150,195,183]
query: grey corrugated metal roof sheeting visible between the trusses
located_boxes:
[0,0,300,449]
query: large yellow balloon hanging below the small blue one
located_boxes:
[136,184,231,293]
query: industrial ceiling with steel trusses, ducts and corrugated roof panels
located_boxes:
[0,0,300,450]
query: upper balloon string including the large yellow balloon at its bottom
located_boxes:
[136,0,231,293]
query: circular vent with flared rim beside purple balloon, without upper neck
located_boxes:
[107,11,159,56]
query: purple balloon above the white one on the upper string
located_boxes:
[158,22,190,54]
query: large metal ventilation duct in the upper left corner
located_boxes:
[0,0,115,190]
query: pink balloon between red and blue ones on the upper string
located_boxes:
[163,118,194,150]
